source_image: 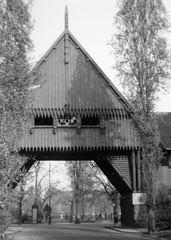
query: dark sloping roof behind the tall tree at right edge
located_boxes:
[158,112,171,148]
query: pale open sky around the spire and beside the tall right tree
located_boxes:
[32,0,171,112]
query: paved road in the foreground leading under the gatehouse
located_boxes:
[14,222,151,240]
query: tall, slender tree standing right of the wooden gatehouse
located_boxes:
[110,0,170,232]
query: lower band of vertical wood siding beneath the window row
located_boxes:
[21,119,139,150]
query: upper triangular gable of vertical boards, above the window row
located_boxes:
[30,29,131,117]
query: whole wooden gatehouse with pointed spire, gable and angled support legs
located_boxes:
[20,8,147,225]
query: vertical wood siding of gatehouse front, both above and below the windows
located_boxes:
[21,31,140,150]
